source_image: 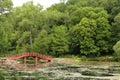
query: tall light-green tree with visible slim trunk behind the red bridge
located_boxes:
[14,1,42,50]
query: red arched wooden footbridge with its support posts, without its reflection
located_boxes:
[6,52,52,65]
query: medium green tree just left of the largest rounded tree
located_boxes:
[50,26,69,55]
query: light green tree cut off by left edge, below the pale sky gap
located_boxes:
[0,14,13,53]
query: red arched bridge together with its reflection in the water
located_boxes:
[6,52,52,69]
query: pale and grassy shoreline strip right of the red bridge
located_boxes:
[52,58,120,65]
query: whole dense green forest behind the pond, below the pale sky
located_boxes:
[0,0,120,58]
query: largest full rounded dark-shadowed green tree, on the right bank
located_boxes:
[71,7,111,55]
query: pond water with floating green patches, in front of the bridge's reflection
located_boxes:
[0,62,120,80]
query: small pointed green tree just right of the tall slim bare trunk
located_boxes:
[33,29,51,54]
